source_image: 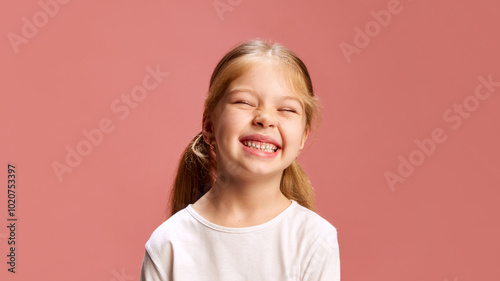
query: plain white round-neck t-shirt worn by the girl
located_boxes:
[141,200,340,281]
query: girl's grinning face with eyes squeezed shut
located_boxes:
[207,61,309,177]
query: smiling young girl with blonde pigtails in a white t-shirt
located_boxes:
[141,40,340,281]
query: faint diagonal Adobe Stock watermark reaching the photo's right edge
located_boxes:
[384,73,500,192]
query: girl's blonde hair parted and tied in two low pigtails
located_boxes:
[169,40,319,215]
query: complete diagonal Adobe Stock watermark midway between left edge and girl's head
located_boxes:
[51,64,169,182]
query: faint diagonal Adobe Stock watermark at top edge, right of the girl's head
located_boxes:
[339,0,411,63]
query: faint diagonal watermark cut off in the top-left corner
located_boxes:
[7,0,69,54]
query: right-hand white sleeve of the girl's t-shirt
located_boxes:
[302,230,340,281]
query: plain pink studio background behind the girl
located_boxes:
[0,0,500,281]
